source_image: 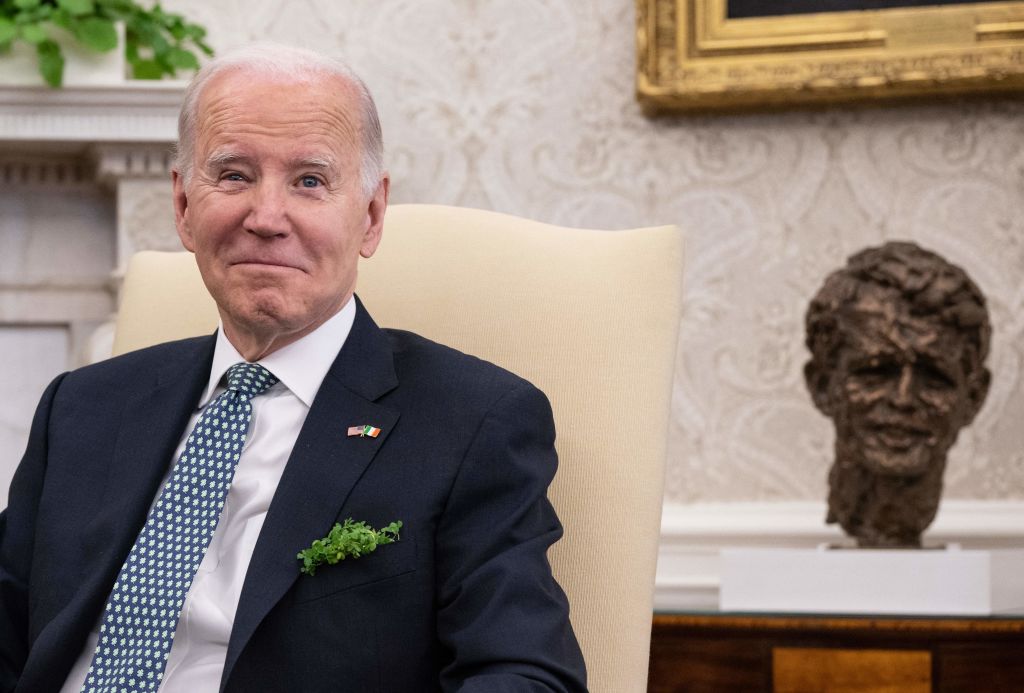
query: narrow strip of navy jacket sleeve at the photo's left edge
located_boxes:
[0,376,63,693]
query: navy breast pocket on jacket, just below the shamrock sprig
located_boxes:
[295,536,416,603]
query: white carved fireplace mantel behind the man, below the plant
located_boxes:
[0,81,186,382]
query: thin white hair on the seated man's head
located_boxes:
[174,42,384,197]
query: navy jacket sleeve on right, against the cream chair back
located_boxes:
[437,382,586,693]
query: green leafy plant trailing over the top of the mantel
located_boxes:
[0,0,213,87]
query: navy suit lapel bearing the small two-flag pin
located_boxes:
[221,299,398,690]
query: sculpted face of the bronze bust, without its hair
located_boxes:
[827,301,987,477]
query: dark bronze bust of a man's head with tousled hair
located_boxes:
[804,243,991,548]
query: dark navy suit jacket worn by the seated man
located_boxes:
[0,304,586,693]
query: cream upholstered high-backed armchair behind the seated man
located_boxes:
[114,205,683,693]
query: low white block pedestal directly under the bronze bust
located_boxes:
[719,546,1024,615]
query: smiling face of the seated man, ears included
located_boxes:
[174,71,387,360]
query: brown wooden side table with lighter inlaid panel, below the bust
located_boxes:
[647,613,1024,693]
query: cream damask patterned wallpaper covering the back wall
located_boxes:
[159,0,1024,503]
